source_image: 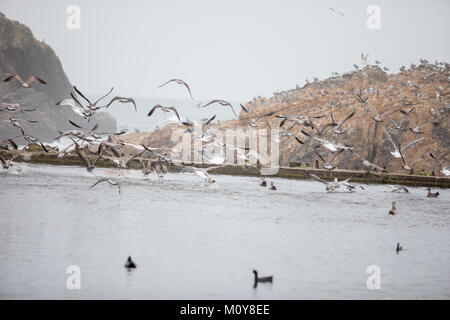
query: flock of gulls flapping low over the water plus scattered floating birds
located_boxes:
[0,53,450,278]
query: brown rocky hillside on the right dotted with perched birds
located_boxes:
[120,60,450,175]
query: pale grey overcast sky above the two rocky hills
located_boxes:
[0,0,450,101]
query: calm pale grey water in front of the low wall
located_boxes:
[0,165,450,299]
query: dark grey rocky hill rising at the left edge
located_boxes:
[0,13,116,142]
